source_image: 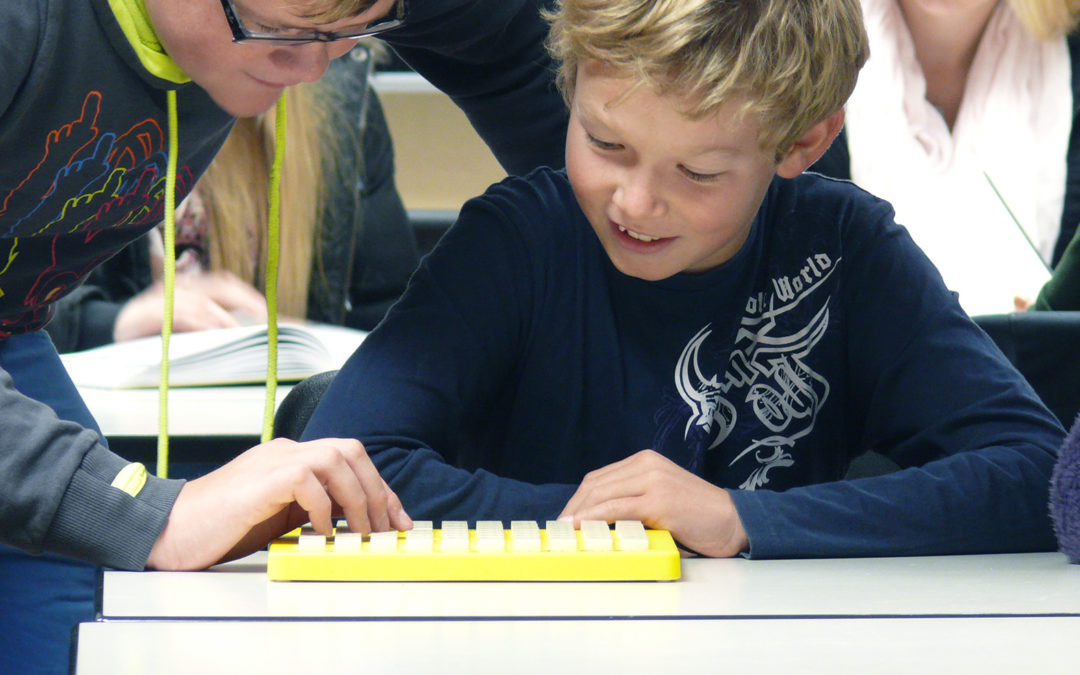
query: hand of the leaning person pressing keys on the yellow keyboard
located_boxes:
[147,438,413,569]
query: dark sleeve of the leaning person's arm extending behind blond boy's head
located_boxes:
[383,0,569,174]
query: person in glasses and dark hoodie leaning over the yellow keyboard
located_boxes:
[0,0,566,673]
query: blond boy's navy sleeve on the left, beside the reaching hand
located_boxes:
[302,192,576,519]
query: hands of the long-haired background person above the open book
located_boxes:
[112,272,267,342]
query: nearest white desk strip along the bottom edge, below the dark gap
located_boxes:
[76,617,1080,675]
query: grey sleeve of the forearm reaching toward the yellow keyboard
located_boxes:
[0,369,183,569]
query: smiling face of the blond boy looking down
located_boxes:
[566,60,778,281]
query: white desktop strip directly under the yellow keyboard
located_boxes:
[102,553,1080,620]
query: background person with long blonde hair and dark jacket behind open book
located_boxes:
[45,42,420,354]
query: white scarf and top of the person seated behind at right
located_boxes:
[846,0,1072,314]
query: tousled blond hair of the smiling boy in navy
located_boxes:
[548,0,869,159]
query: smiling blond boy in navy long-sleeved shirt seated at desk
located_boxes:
[306,0,1062,557]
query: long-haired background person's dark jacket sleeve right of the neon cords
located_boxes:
[345,90,420,330]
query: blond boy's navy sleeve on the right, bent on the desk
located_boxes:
[732,204,1064,557]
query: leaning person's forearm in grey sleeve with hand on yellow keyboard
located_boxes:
[0,358,411,569]
